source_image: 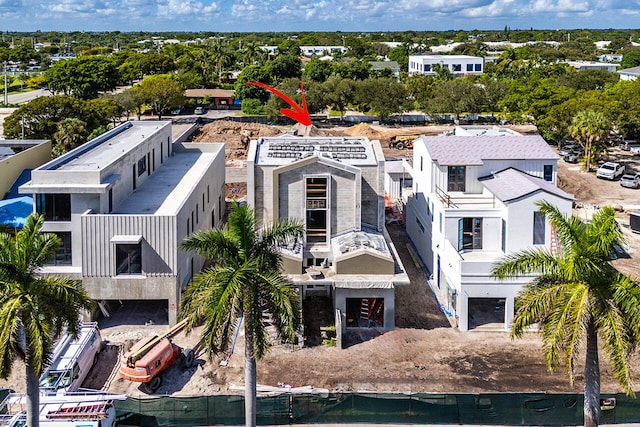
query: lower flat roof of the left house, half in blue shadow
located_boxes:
[111,144,223,215]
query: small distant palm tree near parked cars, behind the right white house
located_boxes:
[569,110,611,172]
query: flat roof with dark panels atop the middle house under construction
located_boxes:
[256,135,377,166]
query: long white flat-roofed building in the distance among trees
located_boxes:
[409,53,484,76]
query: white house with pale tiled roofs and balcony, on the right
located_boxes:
[406,132,574,331]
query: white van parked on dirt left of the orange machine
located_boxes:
[40,322,102,395]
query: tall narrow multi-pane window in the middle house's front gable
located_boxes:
[306,177,329,243]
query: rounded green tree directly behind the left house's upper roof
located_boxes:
[138,74,185,120]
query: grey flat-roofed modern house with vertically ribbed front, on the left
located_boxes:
[19,121,225,324]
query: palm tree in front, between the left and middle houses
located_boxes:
[180,202,303,426]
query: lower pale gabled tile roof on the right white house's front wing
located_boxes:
[478,168,575,202]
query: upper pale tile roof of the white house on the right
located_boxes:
[420,135,559,166]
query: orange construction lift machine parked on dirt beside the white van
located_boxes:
[118,319,195,393]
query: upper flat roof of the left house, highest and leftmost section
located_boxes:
[40,121,171,172]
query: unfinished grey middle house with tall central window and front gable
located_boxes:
[247,136,409,343]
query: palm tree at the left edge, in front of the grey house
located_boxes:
[0,213,94,426]
